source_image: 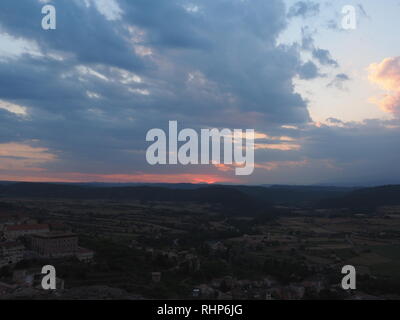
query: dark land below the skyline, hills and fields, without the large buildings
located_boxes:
[0,183,400,299]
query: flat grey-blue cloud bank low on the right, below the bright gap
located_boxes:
[253,118,400,185]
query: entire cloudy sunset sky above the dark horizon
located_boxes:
[0,0,400,185]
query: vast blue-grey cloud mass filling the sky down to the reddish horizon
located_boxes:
[0,0,400,183]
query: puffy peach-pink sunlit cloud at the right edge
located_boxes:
[368,57,400,116]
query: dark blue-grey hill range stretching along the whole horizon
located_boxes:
[0,182,400,212]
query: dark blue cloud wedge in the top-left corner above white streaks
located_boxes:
[0,0,143,70]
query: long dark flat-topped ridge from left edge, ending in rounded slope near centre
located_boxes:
[0,183,269,215]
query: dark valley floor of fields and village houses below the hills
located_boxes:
[0,200,400,300]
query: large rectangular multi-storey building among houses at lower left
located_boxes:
[31,232,79,258]
